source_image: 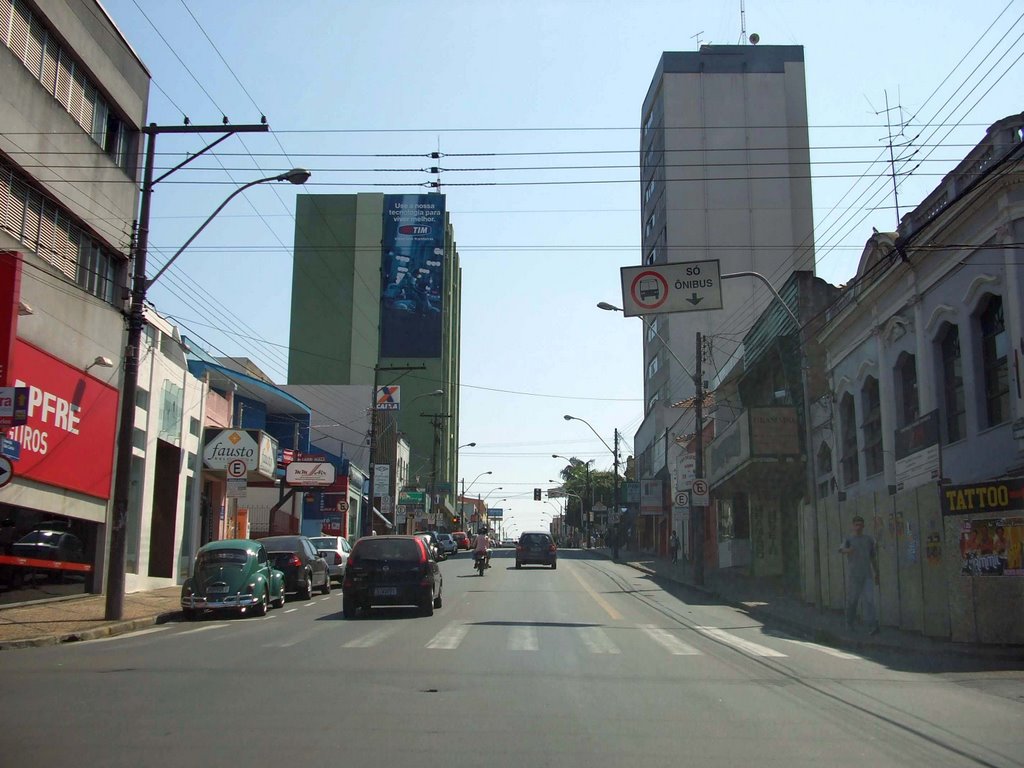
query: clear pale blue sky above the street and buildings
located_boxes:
[102,0,1024,534]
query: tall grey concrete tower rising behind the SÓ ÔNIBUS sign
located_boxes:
[634,45,814,534]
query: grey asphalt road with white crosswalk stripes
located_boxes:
[0,550,1024,768]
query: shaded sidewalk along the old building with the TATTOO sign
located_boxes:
[592,549,1024,662]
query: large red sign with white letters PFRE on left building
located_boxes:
[7,339,118,499]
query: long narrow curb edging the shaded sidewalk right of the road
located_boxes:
[602,553,1024,662]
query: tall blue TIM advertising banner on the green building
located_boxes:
[381,194,444,357]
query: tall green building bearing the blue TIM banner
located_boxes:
[288,194,462,527]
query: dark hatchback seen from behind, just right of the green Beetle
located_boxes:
[341,536,443,618]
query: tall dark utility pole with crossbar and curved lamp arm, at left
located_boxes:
[104,124,310,621]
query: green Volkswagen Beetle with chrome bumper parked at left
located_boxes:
[181,539,285,620]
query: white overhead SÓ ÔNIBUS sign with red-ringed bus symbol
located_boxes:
[621,259,722,317]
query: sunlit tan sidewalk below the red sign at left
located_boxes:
[0,587,181,650]
